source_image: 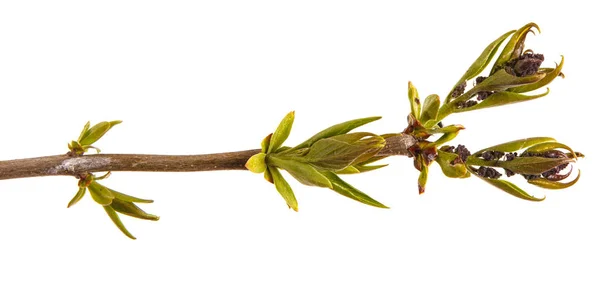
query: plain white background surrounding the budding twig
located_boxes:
[0,1,600,301]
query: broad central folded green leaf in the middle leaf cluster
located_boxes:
[297,132,385,171]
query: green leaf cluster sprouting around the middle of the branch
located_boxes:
[246,112,387,211]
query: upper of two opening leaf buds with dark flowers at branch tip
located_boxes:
[438,23,564,120]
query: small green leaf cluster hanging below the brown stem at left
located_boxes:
[67,174,159,239]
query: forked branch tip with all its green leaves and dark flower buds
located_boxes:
[404,23,579,200]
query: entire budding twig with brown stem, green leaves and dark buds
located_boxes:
[0,23,583,239]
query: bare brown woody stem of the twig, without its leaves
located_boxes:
[0,135,415,180]
